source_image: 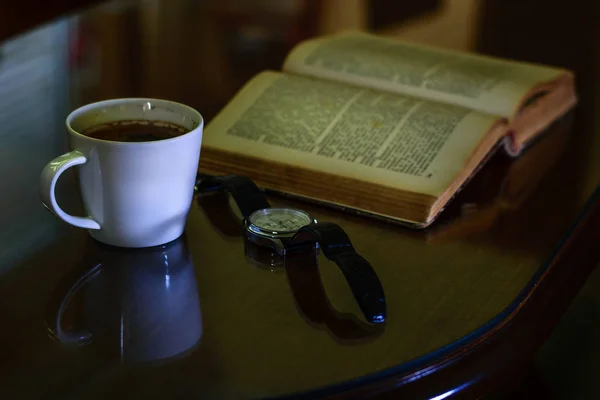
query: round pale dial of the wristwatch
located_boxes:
[248,208,313,235]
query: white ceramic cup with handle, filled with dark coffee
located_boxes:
[40,98,204,248]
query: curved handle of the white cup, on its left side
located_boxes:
[40,150,100,229]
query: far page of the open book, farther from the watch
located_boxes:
[283,33,564,118]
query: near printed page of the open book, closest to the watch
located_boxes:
[203,72,497,196]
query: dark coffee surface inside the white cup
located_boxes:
[83,121,189,142]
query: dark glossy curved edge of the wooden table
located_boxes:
[270,186,600,399]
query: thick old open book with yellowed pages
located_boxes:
[200,33,577,227]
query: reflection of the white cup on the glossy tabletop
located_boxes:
[48,236,202,363]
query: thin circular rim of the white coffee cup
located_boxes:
[65,97,204,146]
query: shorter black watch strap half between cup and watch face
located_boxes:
[196,174,271,218]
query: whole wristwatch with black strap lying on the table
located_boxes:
[196,174,386,323]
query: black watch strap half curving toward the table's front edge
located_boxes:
[286,222,386,323]
